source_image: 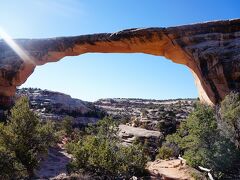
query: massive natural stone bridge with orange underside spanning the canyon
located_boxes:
[0,19,240,106]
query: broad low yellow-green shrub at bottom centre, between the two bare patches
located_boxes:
[68,136,147,177]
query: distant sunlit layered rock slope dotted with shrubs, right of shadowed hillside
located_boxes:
[94,98,196,132]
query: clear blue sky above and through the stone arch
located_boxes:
[0,0,240,101]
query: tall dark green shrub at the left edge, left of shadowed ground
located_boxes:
[0,98,55,177]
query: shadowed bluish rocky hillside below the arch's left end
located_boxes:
[16,88,104,125]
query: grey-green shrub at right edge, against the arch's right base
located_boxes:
[218,92,240,149]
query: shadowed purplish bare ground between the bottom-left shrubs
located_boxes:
[36,147,71,179]
